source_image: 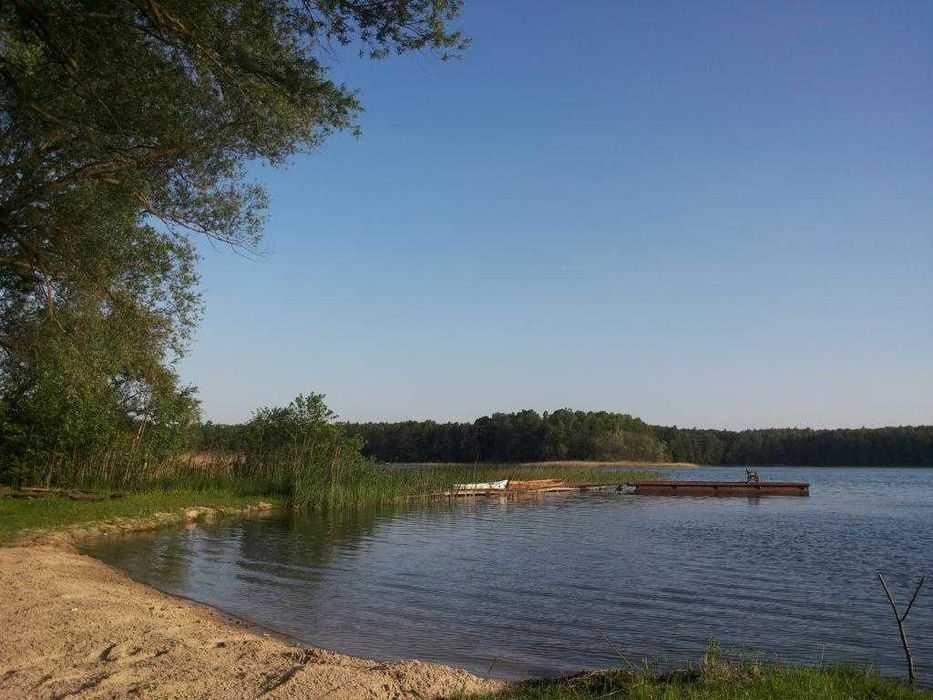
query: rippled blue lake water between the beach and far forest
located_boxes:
[87,468,933,682]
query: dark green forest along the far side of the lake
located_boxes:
[200,409,933,466]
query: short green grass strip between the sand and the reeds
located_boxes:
[0,489,281,542]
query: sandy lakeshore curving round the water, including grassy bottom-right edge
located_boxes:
[0,501,933,700]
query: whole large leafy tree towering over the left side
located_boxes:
[0,0,464,482]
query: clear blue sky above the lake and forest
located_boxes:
[181,0,933,428]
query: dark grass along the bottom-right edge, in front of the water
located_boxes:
[463,662,933,700]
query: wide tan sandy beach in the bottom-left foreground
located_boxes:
[0,546,498,700]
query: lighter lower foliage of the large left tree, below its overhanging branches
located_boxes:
[0,178,198,483]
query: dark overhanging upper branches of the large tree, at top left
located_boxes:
[0,0,465,260]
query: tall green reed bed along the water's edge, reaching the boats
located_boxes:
[1,440,657,510]
